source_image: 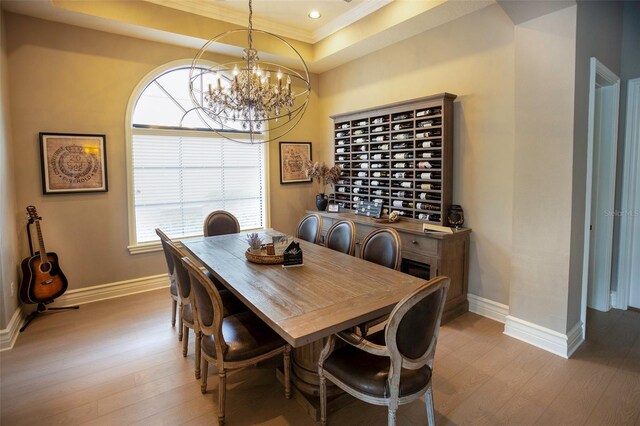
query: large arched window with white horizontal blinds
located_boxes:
[126,62,267,253]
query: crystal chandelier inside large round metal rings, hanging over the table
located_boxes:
[189,0,311,143]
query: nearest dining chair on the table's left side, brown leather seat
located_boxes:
[182,257,291,425]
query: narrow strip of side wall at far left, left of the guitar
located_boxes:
[0,14,20,329]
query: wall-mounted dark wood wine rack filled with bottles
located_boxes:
[331,93,456,225]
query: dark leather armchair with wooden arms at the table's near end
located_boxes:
[318,276,450,426]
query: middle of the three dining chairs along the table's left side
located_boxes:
[165,240,246,379]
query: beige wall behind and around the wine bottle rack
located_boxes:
[320,5,514,304]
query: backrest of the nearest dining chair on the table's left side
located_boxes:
[180,257,226,352]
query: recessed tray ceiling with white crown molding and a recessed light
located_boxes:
[0,0,495,73]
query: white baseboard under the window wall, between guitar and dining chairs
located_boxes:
[50,274,169,307]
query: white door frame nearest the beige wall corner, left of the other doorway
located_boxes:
[580,57,620,338]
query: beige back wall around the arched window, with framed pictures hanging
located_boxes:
[6,14,317,296]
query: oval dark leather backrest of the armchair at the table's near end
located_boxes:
[385,276,451,370]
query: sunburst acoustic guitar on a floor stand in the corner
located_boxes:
[20,206,68,303]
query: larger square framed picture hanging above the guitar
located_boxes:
[40,133,108,194]
